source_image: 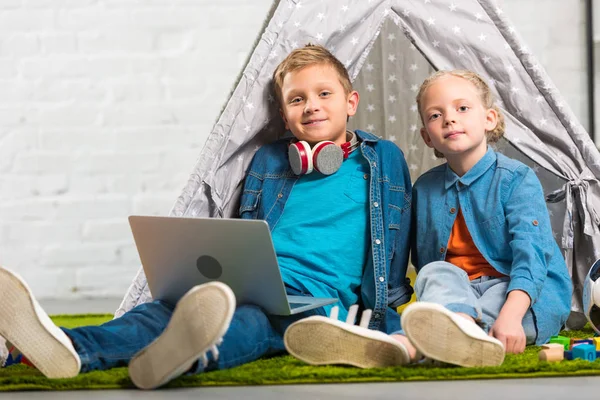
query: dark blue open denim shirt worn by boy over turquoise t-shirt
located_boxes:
[240,131,412,333]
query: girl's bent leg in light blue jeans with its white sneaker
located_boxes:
[402,261,504,367]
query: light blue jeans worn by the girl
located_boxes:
[396,261,537,344]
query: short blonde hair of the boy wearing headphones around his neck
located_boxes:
[273,43,352,104]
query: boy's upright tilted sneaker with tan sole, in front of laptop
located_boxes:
[129,282,235,389]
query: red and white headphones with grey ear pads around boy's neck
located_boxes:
[288,131,359,175]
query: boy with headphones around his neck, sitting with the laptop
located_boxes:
[0,45,412,389]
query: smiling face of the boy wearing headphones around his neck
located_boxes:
[280,64,358,146]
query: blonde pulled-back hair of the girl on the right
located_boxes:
[417,69,504,158]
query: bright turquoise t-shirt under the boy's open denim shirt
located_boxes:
[272,150,370,320]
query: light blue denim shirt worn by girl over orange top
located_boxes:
[412,148,572,344]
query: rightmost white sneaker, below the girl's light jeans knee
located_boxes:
[402,302,505,367]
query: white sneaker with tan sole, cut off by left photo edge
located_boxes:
[0,267,81,378]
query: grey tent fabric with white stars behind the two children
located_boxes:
[115,0,600,327]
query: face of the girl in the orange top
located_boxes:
[419,75,498,161]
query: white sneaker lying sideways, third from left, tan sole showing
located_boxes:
[283,306,410,368]
